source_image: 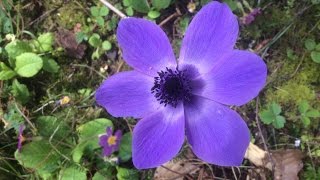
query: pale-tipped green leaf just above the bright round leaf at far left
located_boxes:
[4,40,32,59]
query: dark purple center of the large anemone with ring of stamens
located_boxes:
[151,68,191,107]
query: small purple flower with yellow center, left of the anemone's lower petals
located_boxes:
[99,127,122,156]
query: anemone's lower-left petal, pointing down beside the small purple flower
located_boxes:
[132,105,185,169]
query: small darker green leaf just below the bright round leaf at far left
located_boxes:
[11,79,30,104]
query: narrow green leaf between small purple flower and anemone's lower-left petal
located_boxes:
[119,132,132,162]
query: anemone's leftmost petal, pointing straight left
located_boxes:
[96,71,159,118]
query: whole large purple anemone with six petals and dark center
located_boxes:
[96,2,267,169]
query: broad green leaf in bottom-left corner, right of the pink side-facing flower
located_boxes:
[14,140,60,173]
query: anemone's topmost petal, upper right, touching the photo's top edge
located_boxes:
[179,1,239,73]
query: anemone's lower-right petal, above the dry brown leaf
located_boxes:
[185,97,250,166]
